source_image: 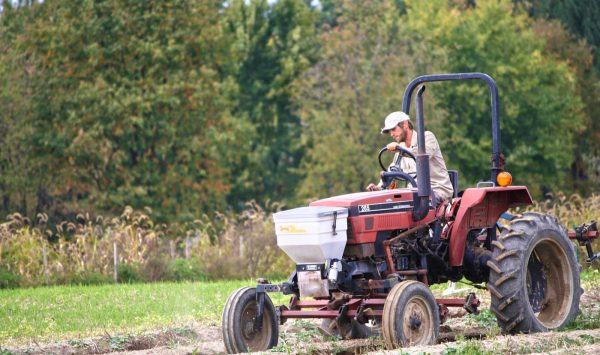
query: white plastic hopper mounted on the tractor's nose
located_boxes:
[273,206,348,265]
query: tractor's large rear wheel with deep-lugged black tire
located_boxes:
[487,212,581,334]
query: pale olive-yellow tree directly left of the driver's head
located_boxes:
[297,1,410,198]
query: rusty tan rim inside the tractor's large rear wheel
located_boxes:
[525,239,573,329]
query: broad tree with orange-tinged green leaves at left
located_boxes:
[2,0,244,220]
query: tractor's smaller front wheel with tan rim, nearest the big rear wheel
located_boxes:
[381,281,440,350]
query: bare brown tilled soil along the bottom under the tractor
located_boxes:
[5,286,600,355]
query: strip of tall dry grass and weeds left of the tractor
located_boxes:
[0,204,291,288]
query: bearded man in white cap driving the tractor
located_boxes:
[367,111,453,206]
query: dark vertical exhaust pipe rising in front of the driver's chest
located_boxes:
[412,85,431,221]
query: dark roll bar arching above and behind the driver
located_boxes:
[402,73,504,183]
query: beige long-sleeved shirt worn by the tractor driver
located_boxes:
[392,131,453,201]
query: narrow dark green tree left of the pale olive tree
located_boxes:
[224,0,318,207]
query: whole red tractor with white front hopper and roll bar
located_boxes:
[222,73,598,353]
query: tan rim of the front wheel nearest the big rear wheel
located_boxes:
[402,297,433,345]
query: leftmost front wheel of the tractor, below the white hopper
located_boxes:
[222,287,279,354]
